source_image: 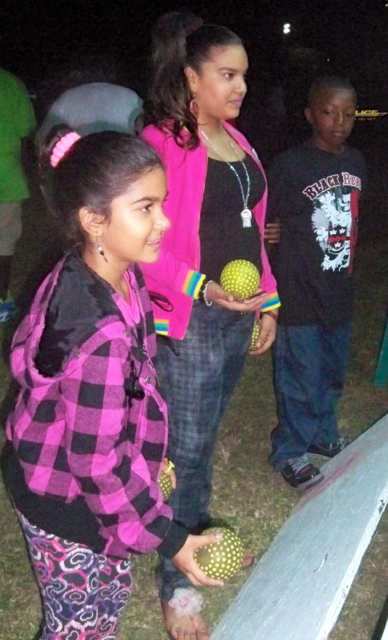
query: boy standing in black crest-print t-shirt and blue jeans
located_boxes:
[269,77,366,490]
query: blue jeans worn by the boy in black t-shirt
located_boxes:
[269,324,350,470]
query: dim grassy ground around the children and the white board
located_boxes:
[0,134,388,640]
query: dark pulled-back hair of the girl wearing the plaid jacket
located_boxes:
[40,125,163,245]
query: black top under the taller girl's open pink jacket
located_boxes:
[199,155,265,282]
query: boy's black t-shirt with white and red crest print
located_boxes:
[267,143,366,328]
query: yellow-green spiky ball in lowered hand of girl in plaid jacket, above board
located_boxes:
[194,527,244,580]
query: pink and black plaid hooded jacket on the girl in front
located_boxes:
[7,254,187,557]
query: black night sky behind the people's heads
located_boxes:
[0,0,388,158]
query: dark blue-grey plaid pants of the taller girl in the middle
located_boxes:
[156,302,254,600]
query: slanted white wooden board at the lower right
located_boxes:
[211,415,388,640]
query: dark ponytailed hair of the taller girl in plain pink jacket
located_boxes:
[145,11,242,149]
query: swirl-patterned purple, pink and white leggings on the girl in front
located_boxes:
[18,513,132,640]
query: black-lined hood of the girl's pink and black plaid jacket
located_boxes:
[11,254,156,387]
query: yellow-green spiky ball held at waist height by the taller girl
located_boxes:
[220,260,260,300]
